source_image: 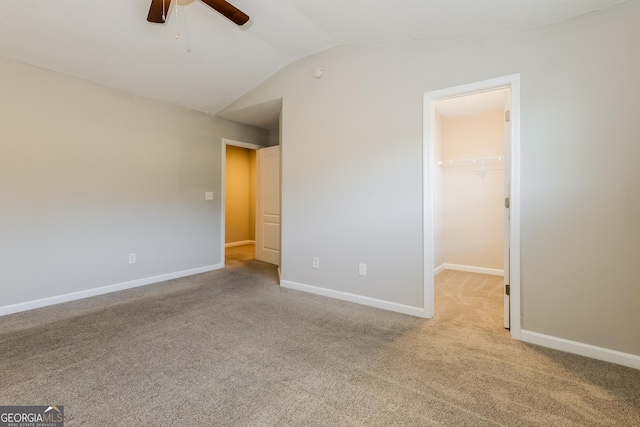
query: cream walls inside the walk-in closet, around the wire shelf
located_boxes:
[436,110,504,270]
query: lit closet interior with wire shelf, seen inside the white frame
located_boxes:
[434,88,509,328]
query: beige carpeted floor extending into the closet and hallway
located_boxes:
[0,247,640,427]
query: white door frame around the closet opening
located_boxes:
[422,74,521,339]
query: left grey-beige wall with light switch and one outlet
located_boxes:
[0,59,268,307]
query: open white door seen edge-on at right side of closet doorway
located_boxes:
[504,89,511,329]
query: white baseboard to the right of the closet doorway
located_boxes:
[520,329,640,369]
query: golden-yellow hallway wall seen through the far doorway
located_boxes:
[225,145,256,243]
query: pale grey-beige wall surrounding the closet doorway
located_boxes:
[222,1,640,355]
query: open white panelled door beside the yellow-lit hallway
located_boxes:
[256,146,280,265]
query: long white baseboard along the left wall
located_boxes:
[0,264,224,316]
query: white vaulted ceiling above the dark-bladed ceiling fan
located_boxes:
[0,0,626,125]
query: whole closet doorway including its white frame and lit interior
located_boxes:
[424,75,520,338]
